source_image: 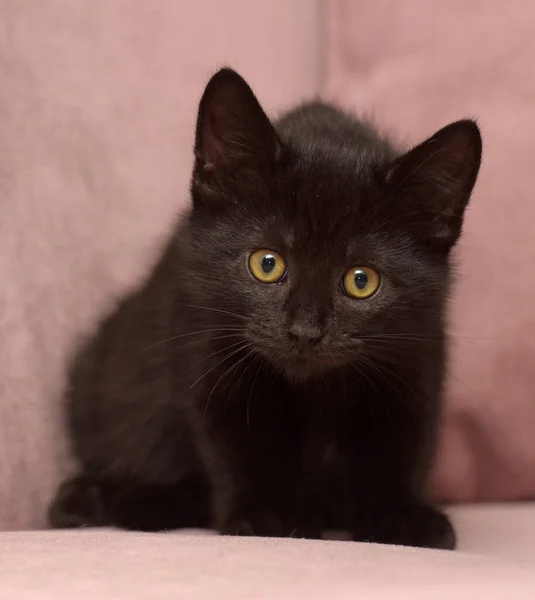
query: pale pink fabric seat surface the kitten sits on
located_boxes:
[0,505,535,600]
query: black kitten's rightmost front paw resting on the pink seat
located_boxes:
[353,504,456,550]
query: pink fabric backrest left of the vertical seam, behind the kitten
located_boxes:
[0,0,319,529]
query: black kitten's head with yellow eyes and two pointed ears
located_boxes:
[190,69,481,380]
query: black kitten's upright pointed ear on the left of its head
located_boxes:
[193,68,279,196]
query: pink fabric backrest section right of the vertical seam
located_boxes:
[326,0,535,500]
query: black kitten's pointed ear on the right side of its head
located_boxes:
[387,120,481,251]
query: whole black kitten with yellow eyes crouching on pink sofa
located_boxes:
[50,69,481,548]
